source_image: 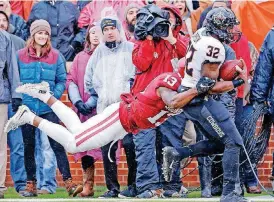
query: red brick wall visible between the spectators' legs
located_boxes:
[6,93,274,187]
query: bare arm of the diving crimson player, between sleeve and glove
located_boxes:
[157,87,198,109]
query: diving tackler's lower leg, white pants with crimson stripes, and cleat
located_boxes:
[5,103,127,153]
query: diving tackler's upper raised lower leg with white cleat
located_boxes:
[16,82,81,133]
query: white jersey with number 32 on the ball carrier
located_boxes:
[182,28,225,88]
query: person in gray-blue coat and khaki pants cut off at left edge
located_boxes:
[0,30,21,198]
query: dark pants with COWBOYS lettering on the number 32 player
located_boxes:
[184,98,243,195]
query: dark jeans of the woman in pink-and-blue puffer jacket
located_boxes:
[22,112,71,181]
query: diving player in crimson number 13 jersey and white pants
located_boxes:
[2,73,218,153]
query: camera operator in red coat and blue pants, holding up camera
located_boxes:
[131,5,189,198]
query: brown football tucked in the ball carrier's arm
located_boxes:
[220,60,244,81]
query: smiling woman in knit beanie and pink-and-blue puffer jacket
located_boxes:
[17,20,83,197]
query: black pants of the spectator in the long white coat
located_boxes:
[101,134,137,191]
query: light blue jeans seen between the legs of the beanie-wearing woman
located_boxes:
[35,130,57,194]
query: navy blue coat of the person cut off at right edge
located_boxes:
[250,28,274,117]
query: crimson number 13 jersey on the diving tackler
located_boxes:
[119,73,182,134]
